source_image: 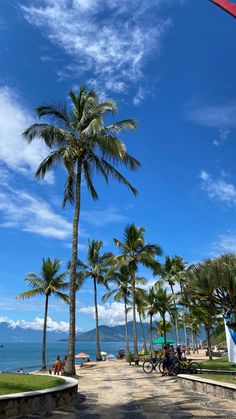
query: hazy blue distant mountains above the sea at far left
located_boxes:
[0,322,68,344]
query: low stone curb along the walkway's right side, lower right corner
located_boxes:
[178,374,236,400]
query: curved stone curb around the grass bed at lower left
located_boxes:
[0,374,78,419]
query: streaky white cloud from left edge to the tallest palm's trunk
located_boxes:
[0,183,72,240]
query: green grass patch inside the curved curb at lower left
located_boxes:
[0,374,65,396]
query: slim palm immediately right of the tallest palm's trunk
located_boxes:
[77,240,111,361]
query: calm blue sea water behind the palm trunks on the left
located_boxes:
[0,342,135,372]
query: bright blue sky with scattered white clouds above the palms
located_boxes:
[0,0,236,330]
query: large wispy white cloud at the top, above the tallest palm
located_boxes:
[21,0,171,97]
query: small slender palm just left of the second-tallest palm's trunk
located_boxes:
[102,266,131,352]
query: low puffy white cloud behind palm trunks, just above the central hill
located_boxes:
[79,301,132,326]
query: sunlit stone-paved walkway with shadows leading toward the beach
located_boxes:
[29,361,236,419]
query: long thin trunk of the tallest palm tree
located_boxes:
[64,160,82,375]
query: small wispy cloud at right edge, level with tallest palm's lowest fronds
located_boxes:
[199,170,236,204]
